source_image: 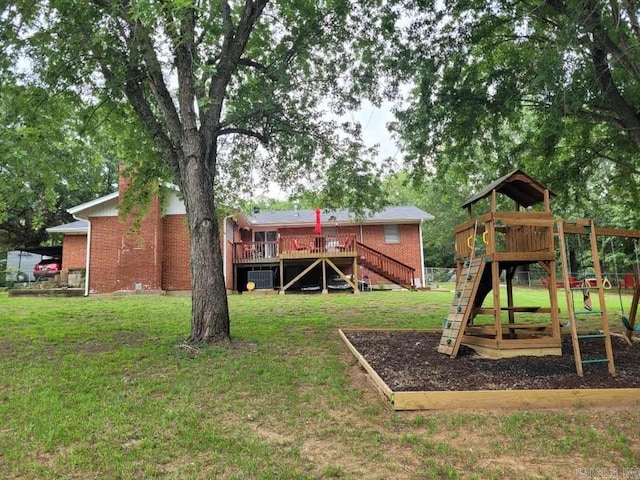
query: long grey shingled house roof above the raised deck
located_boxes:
[247,205,434,227]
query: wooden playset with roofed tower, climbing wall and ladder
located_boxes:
[438,170,640,375]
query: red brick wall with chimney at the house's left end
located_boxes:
[89,199,163,293]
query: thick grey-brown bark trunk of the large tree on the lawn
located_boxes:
[182,157,230,343]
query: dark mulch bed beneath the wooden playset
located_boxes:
[345,331,640,392]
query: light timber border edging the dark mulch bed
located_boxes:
[338,328,640,410]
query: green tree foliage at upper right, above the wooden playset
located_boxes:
[392,0,640,224]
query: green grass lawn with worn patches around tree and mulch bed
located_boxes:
[0,289,640,479]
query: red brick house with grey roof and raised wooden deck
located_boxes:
[47,178,433,294]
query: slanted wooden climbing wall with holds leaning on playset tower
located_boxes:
[438,257,485,357]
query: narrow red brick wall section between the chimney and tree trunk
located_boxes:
[162,215,191,290]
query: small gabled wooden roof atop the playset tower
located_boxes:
[462,169,556,208]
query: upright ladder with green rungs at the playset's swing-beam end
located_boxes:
[556,220,616,376]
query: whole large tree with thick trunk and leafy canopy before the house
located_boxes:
[0,0,394,342]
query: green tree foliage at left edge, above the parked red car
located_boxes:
[0,81,117,249]
